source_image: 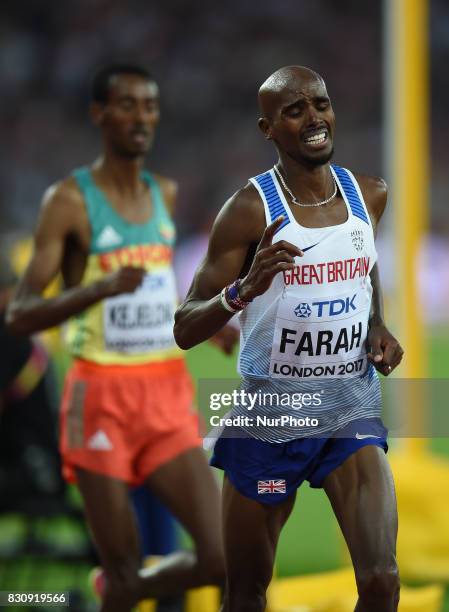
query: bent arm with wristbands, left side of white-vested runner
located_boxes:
[174,187,302,349]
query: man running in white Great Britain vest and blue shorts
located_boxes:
[175,66,402,612]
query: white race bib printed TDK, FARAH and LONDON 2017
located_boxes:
[270,290,371,379]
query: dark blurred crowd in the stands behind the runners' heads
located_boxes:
[0,0,449,320]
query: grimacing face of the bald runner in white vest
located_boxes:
[269,78,335,166]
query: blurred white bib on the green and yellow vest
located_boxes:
[103,269,177,354]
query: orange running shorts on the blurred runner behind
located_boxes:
[60,359,201,485]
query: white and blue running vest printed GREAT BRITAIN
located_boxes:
[233,166,380,442]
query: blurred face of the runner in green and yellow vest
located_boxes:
[98,75,160,158]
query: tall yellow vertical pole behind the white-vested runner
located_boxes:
[386,0,429,453]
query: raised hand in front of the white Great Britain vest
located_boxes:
[239,215,304,300]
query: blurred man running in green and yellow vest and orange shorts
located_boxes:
[8,65,224,612]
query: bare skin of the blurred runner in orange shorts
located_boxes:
[8,74,226,612]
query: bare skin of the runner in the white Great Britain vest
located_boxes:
[175,66,403,612]
